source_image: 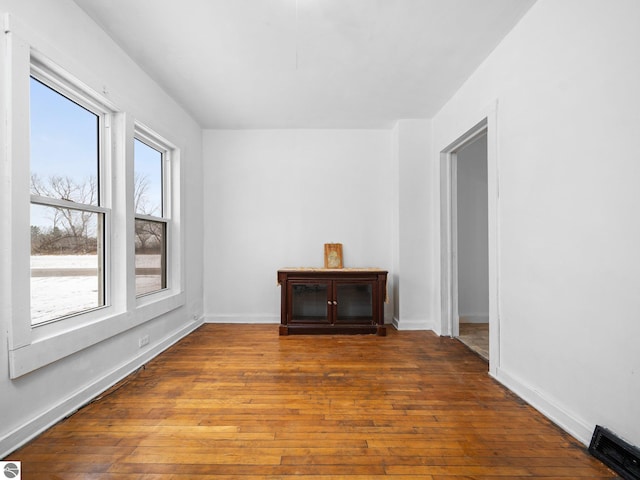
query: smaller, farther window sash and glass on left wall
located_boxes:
[134,131,169,296]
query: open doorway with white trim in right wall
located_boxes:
[440,109,500,376]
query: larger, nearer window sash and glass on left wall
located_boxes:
[30,76,109,325]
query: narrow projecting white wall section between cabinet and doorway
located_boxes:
[390,120,435,330]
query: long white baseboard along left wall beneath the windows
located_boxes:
[0,319,203,458]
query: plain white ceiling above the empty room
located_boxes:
[75,0,535,128]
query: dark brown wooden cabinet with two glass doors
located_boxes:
[278,268,387,335]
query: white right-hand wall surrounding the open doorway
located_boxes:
[425,0,640,445]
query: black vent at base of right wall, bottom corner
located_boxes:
[589,425,640,480]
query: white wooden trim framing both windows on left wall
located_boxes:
[0,22,185,378]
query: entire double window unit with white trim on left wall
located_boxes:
[5,31,186,378]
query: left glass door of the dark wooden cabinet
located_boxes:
[289,282,330,323]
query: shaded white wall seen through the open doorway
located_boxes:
[456,135,489,323]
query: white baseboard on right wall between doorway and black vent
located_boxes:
[492,368,595,446]
